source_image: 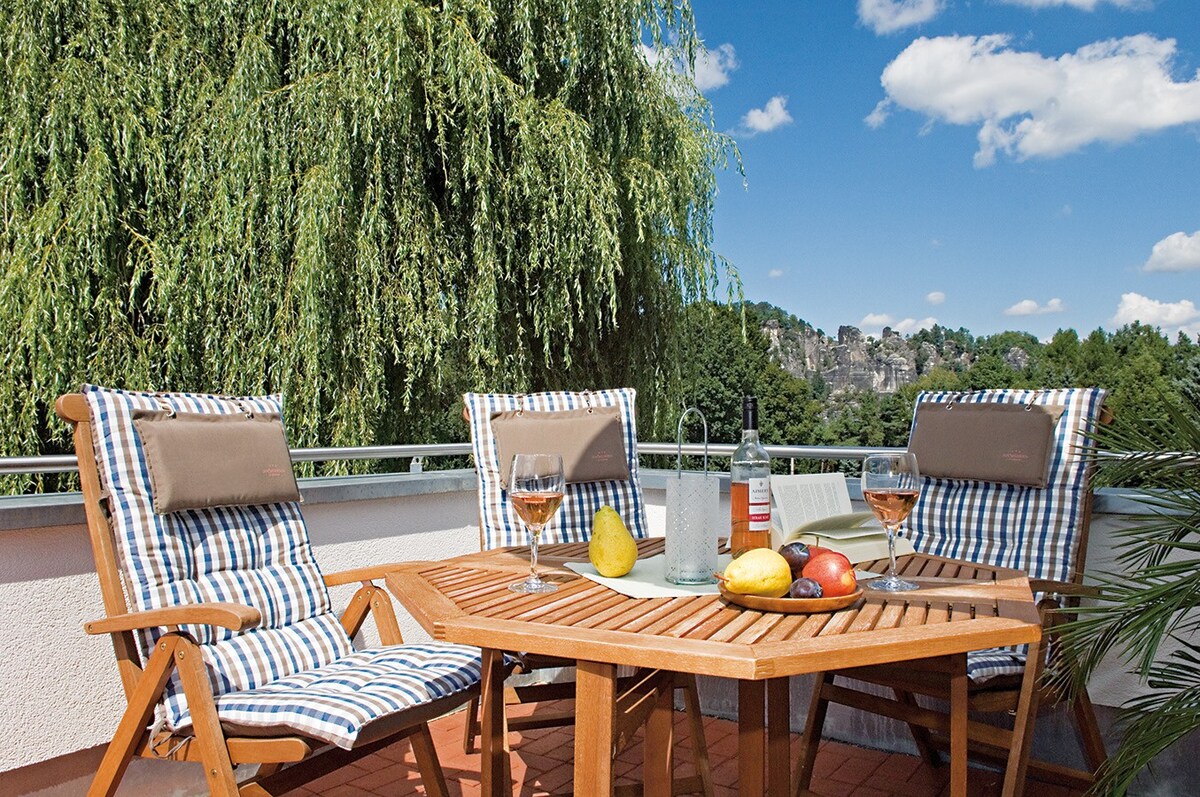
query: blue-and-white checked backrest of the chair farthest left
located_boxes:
[59,385,353,727]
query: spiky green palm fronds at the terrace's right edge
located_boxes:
[1058,396,1200,795]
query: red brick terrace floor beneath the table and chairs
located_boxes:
[276,712,1082,797]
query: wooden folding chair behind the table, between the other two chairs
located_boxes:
[463,388,713,797]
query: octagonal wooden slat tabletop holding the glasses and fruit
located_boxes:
[388,538,1040,679]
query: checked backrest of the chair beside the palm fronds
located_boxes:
[908,388,1105,581]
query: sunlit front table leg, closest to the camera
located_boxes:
[575,661,617,796]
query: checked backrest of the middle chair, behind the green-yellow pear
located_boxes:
[463,388,648,549]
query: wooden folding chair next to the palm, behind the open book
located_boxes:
[796,389,1105,795]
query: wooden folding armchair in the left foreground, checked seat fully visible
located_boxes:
[56,385,480,797]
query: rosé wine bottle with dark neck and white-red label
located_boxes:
[730,396,770,556]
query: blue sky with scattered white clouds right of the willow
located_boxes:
[692,0,1200,340]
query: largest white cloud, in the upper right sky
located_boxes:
[868,34,1200,167]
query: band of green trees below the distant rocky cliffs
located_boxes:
[681,302,1200,480]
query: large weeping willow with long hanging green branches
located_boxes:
[0,0,730,480]
